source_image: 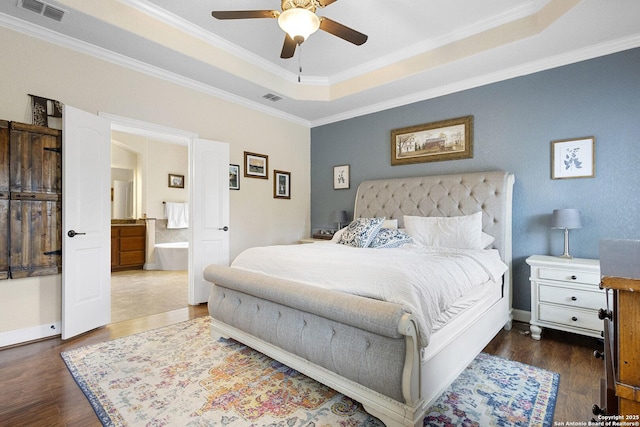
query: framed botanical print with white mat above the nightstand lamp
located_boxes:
[551,136,596,179]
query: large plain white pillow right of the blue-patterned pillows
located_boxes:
[404,211,483,249]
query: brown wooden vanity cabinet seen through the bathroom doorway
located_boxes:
[111,224,147,271]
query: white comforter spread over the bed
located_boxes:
[232,243,507,347]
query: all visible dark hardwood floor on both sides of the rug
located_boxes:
[0,312,603,427]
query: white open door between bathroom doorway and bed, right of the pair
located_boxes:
[189,139,230,305]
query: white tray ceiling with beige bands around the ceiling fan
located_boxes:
[0,0,640,126]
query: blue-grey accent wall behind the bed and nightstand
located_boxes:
[311,49,640,310]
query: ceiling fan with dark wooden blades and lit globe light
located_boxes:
[211,0,367,59]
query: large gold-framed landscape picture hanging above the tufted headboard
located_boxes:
[391,116,473,166]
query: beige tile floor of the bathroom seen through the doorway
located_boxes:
[111,270,188,323]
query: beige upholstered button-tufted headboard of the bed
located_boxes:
[354,171,514,266]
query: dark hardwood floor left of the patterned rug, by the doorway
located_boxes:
[0,304,209,427]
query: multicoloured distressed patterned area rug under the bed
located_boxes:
[62,317,559,427]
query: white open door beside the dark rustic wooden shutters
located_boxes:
[62,106,111,339]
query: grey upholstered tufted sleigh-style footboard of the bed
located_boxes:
[204,265,421,425]
